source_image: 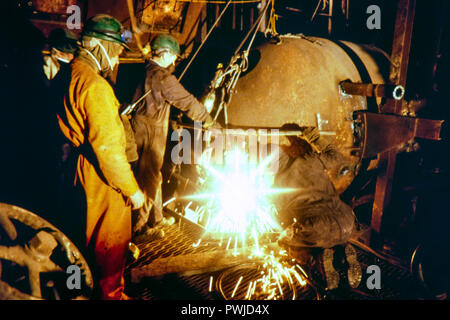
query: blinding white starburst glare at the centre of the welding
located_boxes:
[185,148,291,243]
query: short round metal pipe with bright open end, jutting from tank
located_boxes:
[339,81,405,100]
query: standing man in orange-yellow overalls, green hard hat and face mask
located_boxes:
[58,15,145,299]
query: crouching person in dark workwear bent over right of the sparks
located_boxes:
[275,124,362,290]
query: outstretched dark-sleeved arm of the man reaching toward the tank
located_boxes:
[161,75,209,121]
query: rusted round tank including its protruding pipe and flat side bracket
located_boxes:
[228,34,442,193]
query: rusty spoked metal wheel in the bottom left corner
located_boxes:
[0,203,93,300]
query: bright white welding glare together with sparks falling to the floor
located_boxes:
[169,148,306,300]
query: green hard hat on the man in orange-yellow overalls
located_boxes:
[83,14,130,50]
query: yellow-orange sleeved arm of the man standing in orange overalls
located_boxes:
[84,83,139,197]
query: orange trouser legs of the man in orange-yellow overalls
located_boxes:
[78,157,131,300]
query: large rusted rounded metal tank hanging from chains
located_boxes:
[228,35,389,192]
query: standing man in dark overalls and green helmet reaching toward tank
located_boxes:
[131,34,213,237]
